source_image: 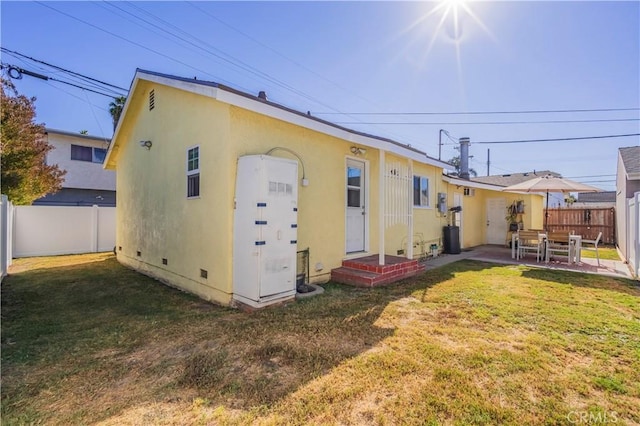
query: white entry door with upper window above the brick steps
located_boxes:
[346,159,367,253]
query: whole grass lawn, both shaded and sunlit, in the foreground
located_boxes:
[2,254,640,425]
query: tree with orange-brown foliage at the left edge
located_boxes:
[0,78,66,205]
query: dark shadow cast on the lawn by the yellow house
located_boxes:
[1,256,470,423]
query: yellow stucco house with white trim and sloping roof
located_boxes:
[105,70,542,307]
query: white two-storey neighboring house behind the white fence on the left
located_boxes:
[33,129,116,207]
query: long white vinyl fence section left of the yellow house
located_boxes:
[13,206,116,258]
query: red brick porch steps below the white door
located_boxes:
[331,255,425,287]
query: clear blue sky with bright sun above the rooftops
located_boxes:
[0,1,640,190]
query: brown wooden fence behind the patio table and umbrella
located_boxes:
[547,207,616,245]
